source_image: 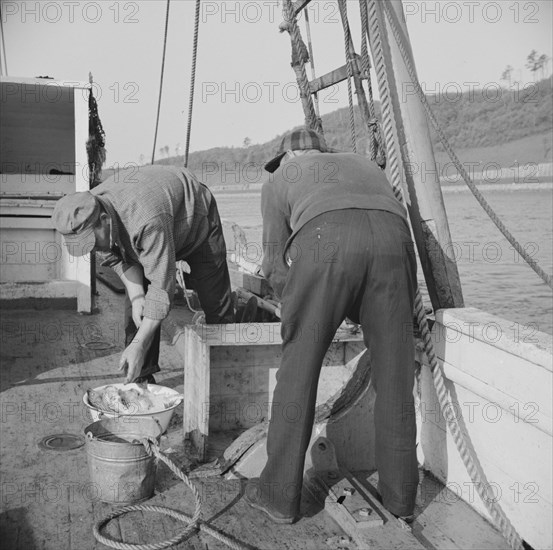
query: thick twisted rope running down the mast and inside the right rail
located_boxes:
[368,0,523,550]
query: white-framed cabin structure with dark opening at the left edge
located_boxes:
[0,77,93,313]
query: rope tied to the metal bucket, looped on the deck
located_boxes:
[93,439,248,550]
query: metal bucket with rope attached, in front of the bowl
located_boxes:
[84,417,162,505]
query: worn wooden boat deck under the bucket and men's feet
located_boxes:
[0,283,507,550]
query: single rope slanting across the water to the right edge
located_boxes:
[382,2,553,289]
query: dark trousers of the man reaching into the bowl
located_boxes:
[125,197,234,377]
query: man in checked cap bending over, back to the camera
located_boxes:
[246,129,418,523]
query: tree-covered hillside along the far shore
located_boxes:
[104,77,553,185]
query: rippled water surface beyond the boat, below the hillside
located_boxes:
[216,186,553,337]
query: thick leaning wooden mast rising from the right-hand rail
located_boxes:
[367,0,463,310]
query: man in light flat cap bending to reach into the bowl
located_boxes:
[52,166,234,383]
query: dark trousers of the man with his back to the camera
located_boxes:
[260,209,418,516]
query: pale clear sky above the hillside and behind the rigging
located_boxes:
[0,0,553,166]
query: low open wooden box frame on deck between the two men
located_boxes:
[183,323,364,461]
